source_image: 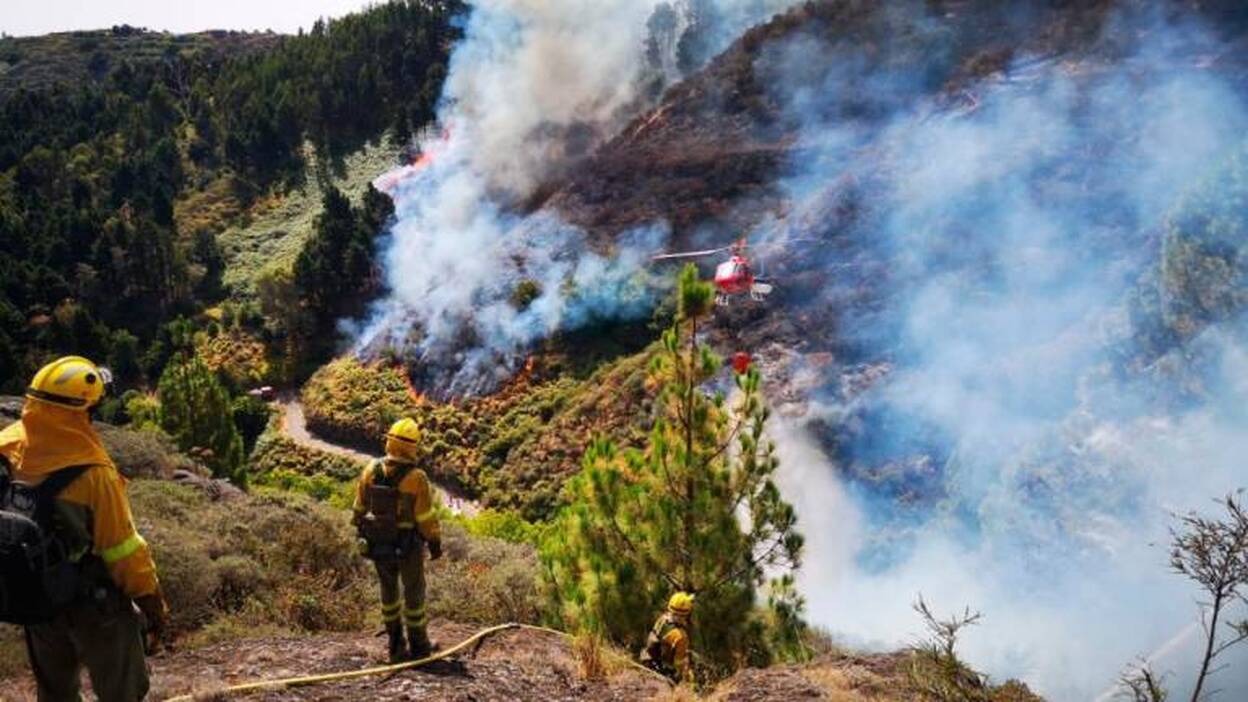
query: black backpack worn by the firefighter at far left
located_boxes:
[0,457,91,625]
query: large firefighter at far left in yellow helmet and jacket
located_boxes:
[0,356,168,702]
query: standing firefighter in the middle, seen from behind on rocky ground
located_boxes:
[353,418,442,663]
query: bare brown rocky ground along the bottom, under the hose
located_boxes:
[0,622,1038,702]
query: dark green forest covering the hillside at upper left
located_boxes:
[0,1,463,392]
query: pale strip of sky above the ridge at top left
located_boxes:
[0,0,368,36]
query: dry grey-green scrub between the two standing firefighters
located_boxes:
[131,481,376,635]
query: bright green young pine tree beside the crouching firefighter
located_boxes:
[542,266,802,675]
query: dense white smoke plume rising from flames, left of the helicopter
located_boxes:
[357,0,784,395]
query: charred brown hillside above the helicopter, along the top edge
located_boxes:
[539,0,1143,243]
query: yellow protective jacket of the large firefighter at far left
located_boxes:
[0,398,160,598]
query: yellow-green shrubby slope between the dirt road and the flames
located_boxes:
[302,350,651,520]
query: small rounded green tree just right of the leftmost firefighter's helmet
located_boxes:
[156,356,247,485]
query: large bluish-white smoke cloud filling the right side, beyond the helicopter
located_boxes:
[766,4,1248,701]
